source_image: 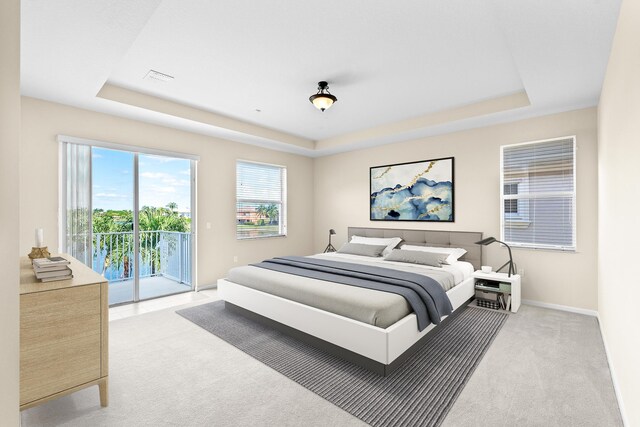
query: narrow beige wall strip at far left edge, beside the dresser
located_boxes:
[0,0,20,426]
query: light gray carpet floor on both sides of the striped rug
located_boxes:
[21,300,622,427]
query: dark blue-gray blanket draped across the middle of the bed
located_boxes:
[252,256,453,331]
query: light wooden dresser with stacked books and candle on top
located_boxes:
[20,254,109,410]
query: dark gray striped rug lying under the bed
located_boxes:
[177,301,509,426]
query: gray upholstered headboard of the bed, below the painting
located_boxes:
[348,227,482,270]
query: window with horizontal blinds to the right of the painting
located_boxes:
[501,137,576,251]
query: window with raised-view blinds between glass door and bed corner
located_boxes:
[236,160,287,239]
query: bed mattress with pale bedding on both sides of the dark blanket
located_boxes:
[227,253,473,328]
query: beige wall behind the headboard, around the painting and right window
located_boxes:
[314,108,597,310]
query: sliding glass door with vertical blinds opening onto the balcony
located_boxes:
[61,143,195,305]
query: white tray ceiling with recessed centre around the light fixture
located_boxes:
[22,0,620,156]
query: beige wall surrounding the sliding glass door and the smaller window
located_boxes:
[20,98,313,285]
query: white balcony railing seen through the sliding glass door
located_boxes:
[93,231,191,285]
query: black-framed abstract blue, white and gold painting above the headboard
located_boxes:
[369,157,454,222]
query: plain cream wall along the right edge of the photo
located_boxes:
[598,0,640,426]
